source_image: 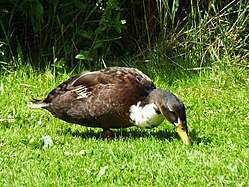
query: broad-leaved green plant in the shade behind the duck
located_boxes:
[76,0,124,61]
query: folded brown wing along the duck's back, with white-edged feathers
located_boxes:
[67,67,155,98]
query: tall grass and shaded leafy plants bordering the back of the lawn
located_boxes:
[0,0,249,68]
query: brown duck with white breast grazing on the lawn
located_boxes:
[29,67,191,145]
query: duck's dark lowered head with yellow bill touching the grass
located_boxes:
[149,89,191,145]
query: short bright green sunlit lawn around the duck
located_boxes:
[0,66,249,187]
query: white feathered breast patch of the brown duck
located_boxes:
[130,102,164,128]
